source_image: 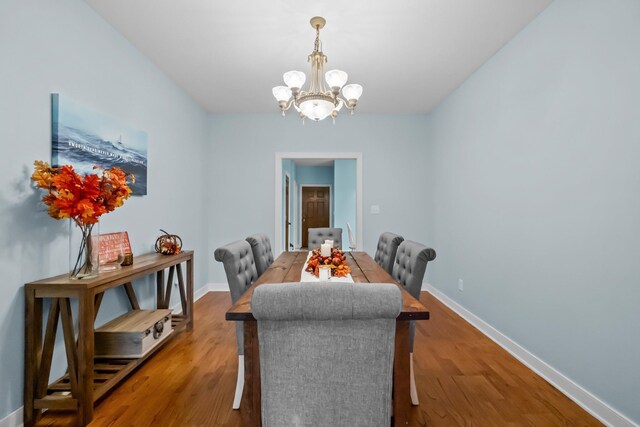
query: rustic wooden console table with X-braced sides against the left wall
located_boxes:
[24,251,193,427]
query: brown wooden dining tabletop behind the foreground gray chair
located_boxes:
[225,251,429,320]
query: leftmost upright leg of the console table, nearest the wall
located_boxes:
[23,287,42,427]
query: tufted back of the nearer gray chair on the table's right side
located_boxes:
[391,240,436,299]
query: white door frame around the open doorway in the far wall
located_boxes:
[273,152,364,256]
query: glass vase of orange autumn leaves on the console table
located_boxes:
[31,160,134,279]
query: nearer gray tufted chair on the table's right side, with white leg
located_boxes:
[391,240,436,405]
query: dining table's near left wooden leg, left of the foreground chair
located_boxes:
[240,321,262,427]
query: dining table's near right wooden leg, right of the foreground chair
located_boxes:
[393,320,411,426]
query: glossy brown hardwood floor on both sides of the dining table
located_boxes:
[38,292,602,427]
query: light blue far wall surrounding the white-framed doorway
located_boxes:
[208,113,433,283]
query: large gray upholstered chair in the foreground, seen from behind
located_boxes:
[251,283,402,427]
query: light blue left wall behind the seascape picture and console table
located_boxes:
[0,0,210,420]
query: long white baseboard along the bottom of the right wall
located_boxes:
[422,283,638,427]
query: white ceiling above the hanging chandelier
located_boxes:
[86,0,551,114]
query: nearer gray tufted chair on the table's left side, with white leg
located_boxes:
[214,240,258,409]
